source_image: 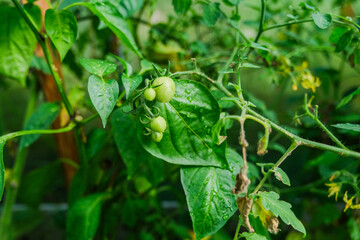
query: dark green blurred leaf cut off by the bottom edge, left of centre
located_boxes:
[66,194,105,240]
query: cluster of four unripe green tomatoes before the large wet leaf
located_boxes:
[144,77,175,142]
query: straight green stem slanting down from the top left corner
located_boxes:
[12,0,75,118]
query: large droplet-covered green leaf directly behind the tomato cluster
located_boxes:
[138,80,227,167]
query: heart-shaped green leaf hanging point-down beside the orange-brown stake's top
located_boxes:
[45,9,78,61]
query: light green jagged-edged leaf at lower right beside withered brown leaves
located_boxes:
[257,192,306,235]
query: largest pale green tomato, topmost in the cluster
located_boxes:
[152,77,175,103]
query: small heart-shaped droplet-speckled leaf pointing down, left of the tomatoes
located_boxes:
[88,75,119,128]
